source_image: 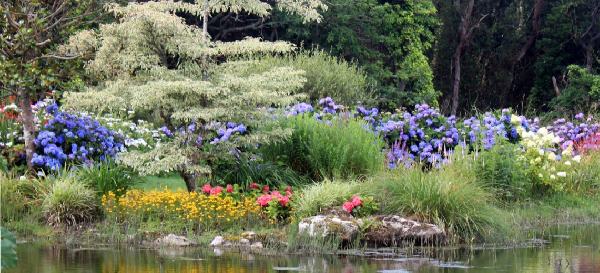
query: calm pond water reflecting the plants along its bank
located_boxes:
[5,224,600,273]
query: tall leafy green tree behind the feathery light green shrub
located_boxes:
[271,0,439,109]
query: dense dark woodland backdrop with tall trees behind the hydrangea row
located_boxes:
[195,0,600,114]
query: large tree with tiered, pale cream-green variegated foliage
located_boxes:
[60,0,326,191]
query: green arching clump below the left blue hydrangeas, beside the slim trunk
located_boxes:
[77,161,139,196]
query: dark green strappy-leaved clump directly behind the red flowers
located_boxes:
[213,156,308,187]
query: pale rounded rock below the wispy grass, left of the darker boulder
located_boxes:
[298,215,360,242]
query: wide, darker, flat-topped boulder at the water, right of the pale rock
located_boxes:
[363,215,446,246]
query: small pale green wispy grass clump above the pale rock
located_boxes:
[296,180,359,217]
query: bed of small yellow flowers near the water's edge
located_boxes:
[102,190,261,226]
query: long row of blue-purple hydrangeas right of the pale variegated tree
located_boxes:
[285,97,600,169]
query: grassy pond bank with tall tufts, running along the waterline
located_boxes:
[2,174,600,249]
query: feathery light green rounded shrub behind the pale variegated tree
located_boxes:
[244,51,371,105]
